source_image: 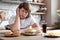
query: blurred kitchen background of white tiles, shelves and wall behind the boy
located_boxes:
[0,0,60,29]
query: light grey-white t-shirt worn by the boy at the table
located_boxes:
[9,15,36,28]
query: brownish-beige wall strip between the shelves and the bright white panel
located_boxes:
[45,0,52,26]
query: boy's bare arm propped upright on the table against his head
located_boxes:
[10,8,20,32]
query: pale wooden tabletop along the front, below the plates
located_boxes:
[0,30,60,40]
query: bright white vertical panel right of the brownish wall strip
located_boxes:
[51,0,58,24]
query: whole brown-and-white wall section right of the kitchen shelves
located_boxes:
[45,0,60,26]
